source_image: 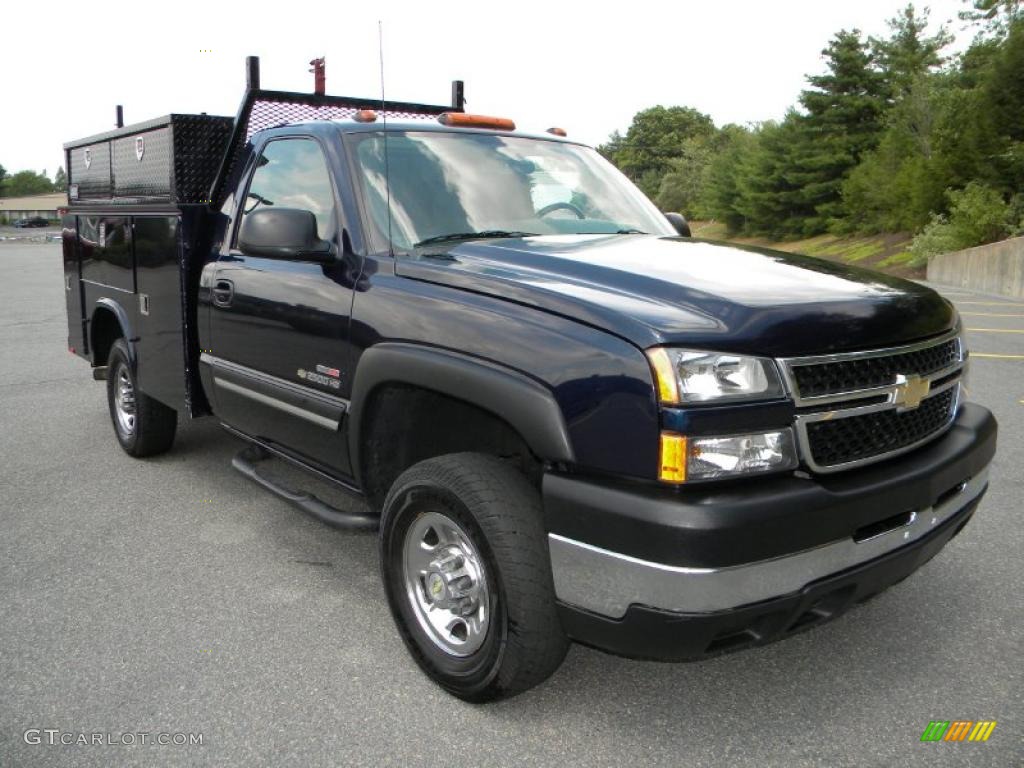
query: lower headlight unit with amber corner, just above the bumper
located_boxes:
[658,428,798,483]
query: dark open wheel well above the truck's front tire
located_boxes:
[359,384,542,509]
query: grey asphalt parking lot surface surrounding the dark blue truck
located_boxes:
[0,243,1024,767]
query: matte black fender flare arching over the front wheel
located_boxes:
[347,342,573,479]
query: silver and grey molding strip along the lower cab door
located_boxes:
[200,352,348,431]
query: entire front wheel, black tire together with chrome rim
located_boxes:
[380,454,568,701]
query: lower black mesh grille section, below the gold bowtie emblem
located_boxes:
[807,386,957,468]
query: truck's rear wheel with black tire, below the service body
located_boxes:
[106,339,178,458]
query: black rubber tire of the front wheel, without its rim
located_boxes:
[380,454,568,701]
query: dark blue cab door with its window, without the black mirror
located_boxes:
[203,135,360,476]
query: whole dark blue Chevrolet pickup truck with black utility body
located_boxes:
[63,61,996,701]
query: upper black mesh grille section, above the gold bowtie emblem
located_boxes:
[792,338,959,398]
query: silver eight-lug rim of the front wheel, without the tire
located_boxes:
[402,512,490,656]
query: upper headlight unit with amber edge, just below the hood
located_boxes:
[647,347,783,406]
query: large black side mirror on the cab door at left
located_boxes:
[239,208,335,264]
